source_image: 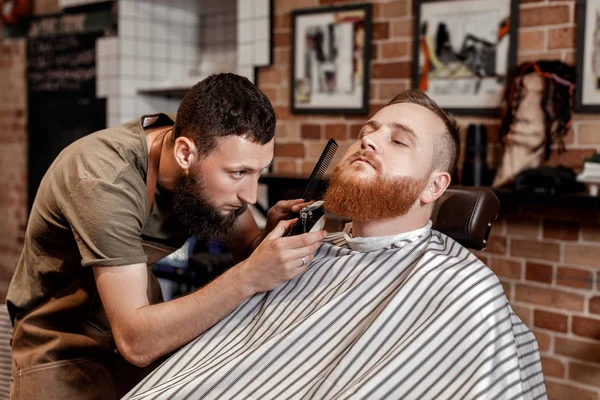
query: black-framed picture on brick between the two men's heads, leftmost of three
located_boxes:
[290,4,371,114]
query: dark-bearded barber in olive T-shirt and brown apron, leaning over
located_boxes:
[7,74,325,399]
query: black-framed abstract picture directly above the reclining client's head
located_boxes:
[413,0,519,116]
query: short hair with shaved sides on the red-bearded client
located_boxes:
[387,89,460,175]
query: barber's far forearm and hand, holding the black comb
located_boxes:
[227,199,308,261]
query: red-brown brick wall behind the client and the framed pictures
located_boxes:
[259,0,600,399]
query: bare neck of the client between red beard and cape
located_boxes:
[352,207,431,237]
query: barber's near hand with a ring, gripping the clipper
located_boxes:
[236,218,327,293]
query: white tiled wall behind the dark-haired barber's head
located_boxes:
[97,0,271,126]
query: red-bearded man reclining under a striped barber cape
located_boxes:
[126,91,546,399]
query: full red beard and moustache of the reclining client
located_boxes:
[324,152,427,221]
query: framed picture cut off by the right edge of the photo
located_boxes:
[574,0,600,112]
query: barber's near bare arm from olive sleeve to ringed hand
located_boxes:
[94,220,325,367]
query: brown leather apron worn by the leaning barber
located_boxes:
[11,133,174,400]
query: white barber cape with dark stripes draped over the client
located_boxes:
[125,230,547,400]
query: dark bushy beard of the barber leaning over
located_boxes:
[173,172,238,241]
